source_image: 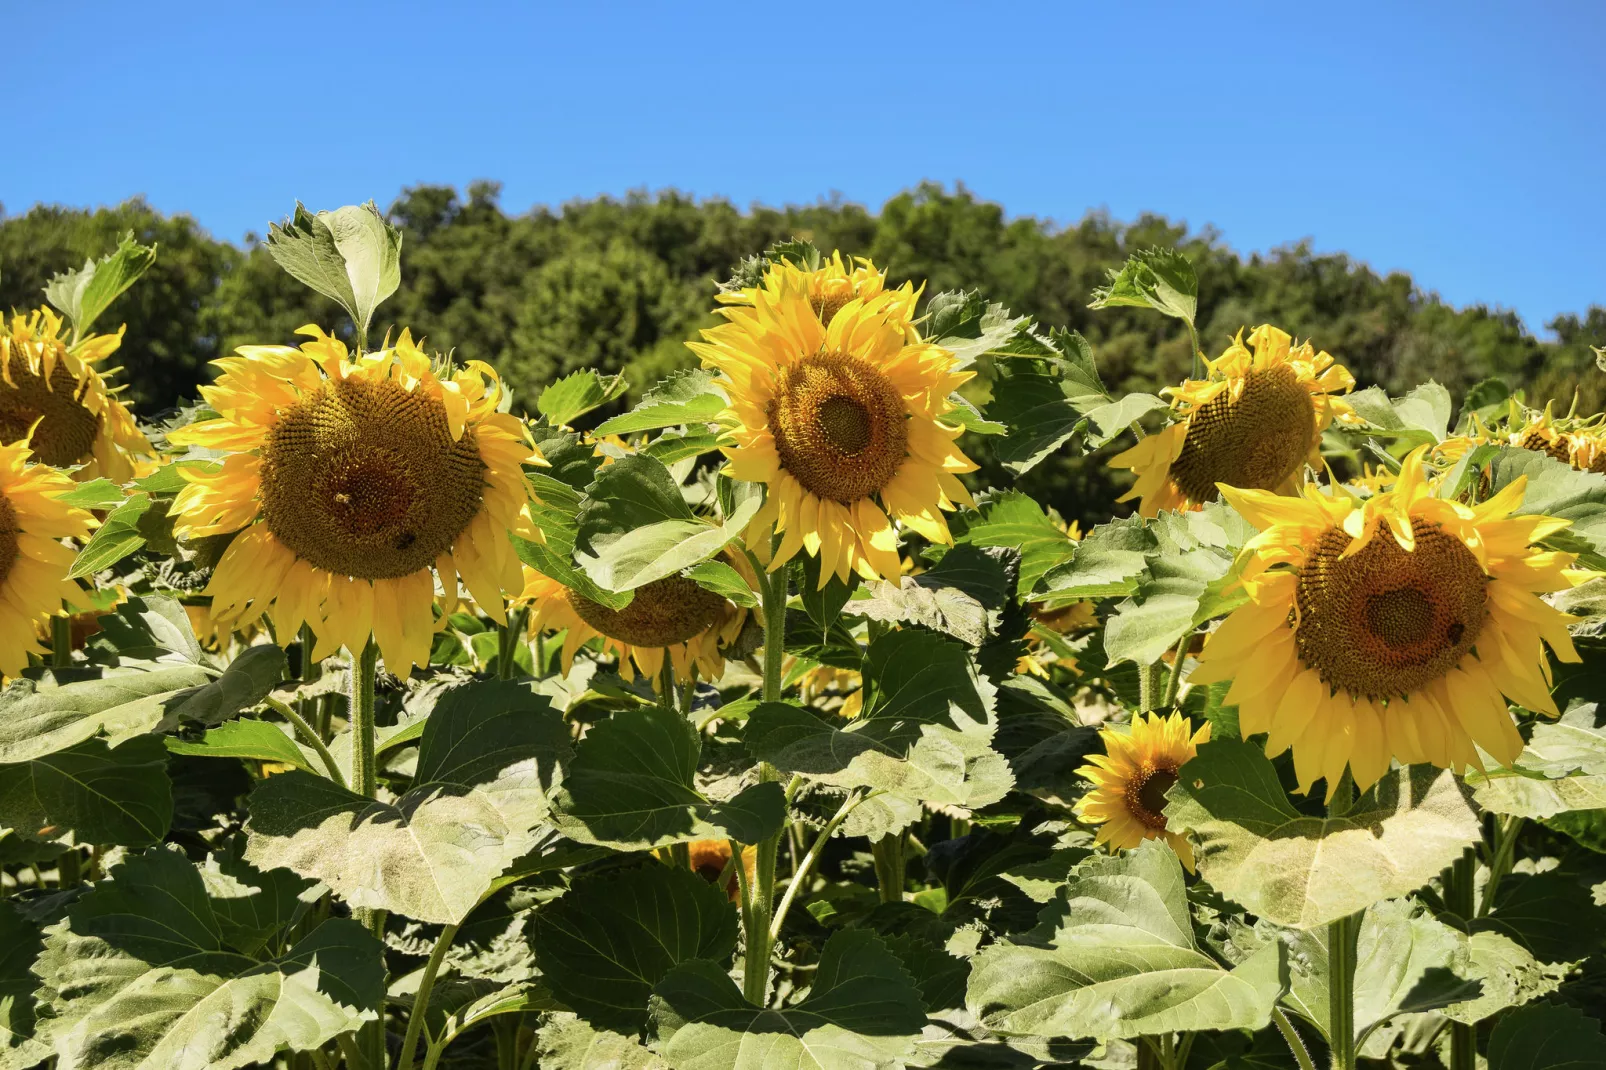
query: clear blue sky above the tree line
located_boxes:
[0,0,1606,331]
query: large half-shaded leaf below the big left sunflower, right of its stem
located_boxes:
[246,681,569,924]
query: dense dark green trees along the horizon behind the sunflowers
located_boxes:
[0,183,1606,521]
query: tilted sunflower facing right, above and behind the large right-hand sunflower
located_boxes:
[1110,325,1355,516]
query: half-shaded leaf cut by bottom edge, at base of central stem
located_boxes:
[652,929,925,1070]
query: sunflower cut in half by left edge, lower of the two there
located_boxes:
[0,439,95,676]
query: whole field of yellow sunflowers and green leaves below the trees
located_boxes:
[0,206,1606,1070]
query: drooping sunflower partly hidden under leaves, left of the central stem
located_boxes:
[517,556,753,686]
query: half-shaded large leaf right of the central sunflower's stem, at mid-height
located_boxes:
[744,630,1013,808]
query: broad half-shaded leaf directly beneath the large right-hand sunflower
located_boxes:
[1166,739,1481,929]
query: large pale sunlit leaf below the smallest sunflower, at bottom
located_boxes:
[968,840,1288,1039]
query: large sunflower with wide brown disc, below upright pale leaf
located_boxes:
[169,326,543,676]
